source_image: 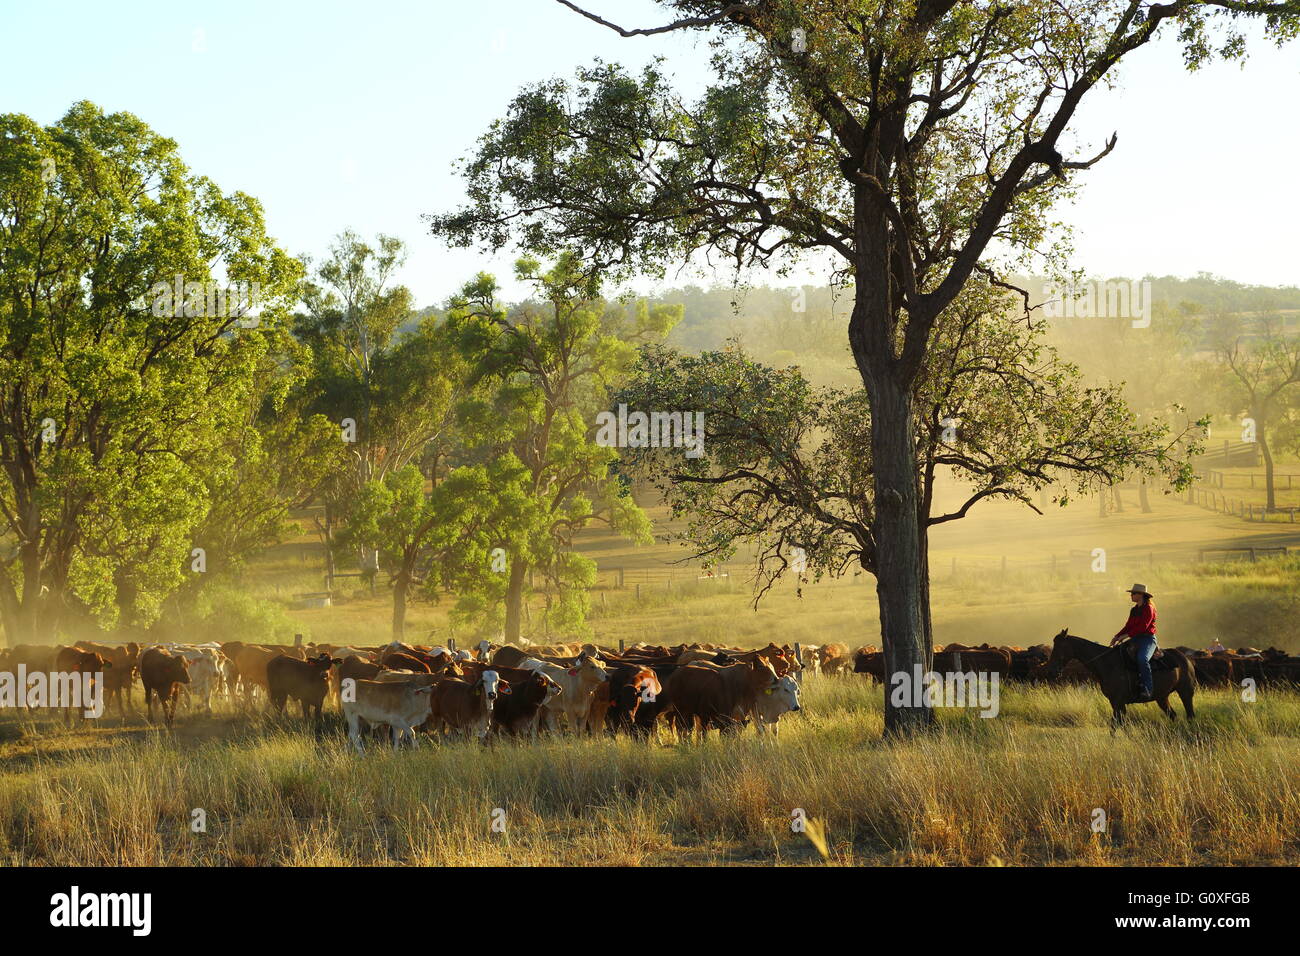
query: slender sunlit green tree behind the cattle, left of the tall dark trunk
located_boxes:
[447,255,681,641]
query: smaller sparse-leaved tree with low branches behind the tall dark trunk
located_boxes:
[618,284,1200,643]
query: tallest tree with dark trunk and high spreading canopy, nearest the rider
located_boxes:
[432,0,1300,732]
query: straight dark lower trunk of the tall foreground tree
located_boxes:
[868,375,935,736]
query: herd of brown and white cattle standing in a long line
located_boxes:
[0,641,1300,750]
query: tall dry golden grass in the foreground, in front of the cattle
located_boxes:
[0,676,1300,866]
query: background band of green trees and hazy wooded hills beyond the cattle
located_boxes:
[0,103,1300,655]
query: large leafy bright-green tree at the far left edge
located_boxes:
[0,103,302,643]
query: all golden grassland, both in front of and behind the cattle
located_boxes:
[10,476,1300,866]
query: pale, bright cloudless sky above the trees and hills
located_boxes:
[0,0,1300,306]
